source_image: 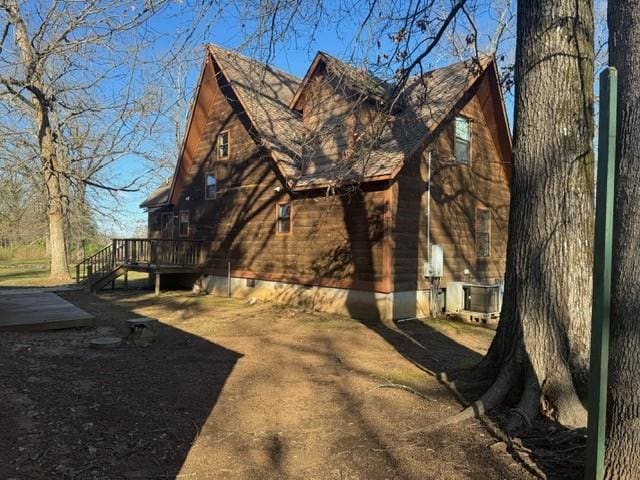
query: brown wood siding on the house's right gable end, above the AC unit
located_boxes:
[393,71,510,291]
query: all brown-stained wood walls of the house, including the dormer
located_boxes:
[149,48,509,298]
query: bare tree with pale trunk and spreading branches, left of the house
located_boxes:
[0,0,209,280]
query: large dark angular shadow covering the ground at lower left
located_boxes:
[0,292,242,479]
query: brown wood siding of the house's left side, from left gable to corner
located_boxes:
[161,55,390,291]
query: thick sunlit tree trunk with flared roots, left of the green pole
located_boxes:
[481,0,594,429]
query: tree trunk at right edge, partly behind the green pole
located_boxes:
[605,0,640,480]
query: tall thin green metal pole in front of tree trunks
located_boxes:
[585,67,618,480]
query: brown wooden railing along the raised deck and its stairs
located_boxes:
[76,238,204,283]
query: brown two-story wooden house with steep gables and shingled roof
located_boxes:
[141,45,511,319]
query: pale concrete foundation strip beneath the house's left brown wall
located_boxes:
[194,275,430,321]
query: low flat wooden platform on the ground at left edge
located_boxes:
[0,292,93,331]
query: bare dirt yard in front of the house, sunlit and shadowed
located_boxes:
[0,290,529,480]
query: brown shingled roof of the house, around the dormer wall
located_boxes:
[141,45,510,208]
